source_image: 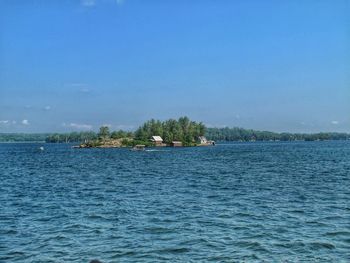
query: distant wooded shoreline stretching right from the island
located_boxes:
[206,127,350,141]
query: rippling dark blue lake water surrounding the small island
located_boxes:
[0,141,350,262]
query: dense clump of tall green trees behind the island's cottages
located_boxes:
[135,117,206,146]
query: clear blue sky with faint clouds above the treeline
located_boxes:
[0,0,350,132]
